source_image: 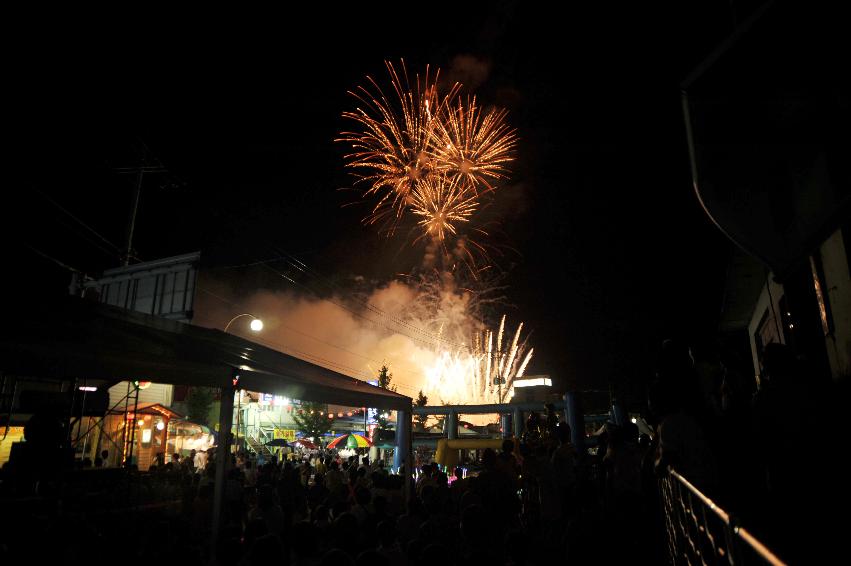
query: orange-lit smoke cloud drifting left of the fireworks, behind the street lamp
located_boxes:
[194,273,460,397]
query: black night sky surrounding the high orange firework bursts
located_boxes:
[3,2,747,404]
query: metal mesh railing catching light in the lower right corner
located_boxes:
[659,468,785,566]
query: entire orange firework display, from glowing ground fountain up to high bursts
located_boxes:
[337,61,533,404]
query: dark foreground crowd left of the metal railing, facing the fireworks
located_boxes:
[0,423,662,566]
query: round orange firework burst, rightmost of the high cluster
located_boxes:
[431,96,517,195]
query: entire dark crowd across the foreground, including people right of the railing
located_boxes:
[0,343,842,566]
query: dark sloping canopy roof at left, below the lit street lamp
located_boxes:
[0,297,411,410]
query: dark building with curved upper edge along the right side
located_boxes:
[682,2,851,386]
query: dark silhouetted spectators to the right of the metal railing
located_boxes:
[647,340,848,563]
